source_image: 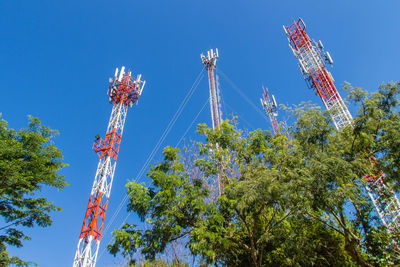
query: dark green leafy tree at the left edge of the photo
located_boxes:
[0,116,67,266]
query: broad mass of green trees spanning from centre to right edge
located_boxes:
[108,83,400,266]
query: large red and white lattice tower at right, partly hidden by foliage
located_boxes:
[283,18,400,243]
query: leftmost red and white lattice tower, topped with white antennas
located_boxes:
[73,67,145,267]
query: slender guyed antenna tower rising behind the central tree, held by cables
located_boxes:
[200,48,221,132]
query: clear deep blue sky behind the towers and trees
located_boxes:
[0,0,400,267]
